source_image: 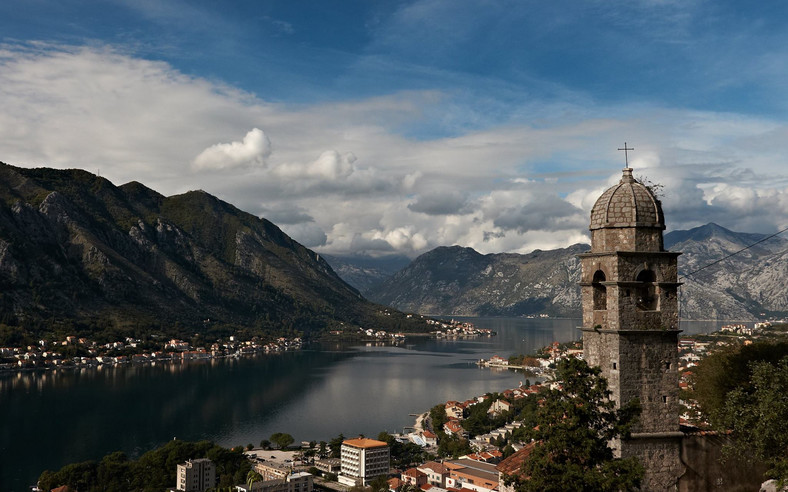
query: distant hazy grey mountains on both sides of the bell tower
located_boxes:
[330,223,788,321]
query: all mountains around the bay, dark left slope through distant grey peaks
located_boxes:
[0,163,788,335]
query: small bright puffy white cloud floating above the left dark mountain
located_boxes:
[194,128,271,170]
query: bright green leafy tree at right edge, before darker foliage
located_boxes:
[712,356,788,486]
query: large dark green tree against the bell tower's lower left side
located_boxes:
[507,357,644,492]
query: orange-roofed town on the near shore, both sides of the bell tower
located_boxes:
[37,322,788,492]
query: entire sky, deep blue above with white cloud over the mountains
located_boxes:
[0,0,788,257]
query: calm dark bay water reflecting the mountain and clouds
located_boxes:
[0,318,719,491]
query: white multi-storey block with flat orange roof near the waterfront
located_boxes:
[338,437,389,487]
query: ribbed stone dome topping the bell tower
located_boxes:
[589,167,665,231]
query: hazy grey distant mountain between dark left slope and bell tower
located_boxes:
[367,245,588,316]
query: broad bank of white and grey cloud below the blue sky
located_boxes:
[0,46,788,262]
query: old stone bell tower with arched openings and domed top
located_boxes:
[580,166,684,490]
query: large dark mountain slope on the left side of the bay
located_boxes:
[0,164,416,331]
